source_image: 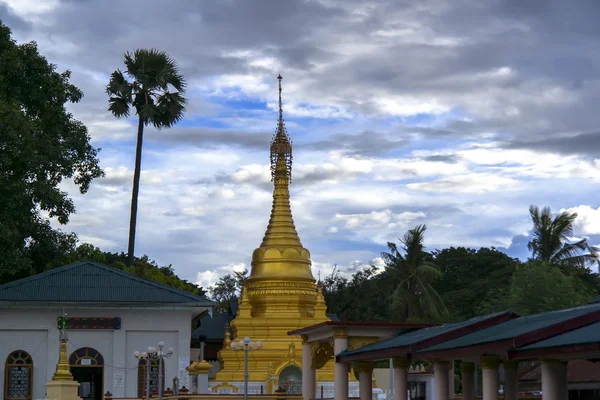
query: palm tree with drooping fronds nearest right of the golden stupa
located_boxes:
[381,225,448,322]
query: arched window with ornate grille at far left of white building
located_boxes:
[4,350,33,400]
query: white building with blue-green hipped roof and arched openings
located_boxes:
[0,261,214,400]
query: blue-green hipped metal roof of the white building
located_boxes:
[0,261,215,307]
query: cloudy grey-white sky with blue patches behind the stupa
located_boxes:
[0,0,600,286]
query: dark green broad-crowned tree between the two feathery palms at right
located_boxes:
[432,247,521,321]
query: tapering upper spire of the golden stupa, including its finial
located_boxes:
[260,75,302,248]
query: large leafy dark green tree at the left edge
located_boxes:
[0,21,103,280]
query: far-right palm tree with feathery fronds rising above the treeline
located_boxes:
[527,206,598,268]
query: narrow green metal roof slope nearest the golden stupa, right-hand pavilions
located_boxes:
[343,312,505,355]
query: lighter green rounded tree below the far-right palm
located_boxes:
[480,260,596,316]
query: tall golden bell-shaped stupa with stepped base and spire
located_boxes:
[213,76,333,393]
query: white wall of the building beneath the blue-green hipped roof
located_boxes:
[0,308,192,400]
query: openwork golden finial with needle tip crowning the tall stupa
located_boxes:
[271,75,292,185]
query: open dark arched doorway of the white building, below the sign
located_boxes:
[69,347,104,400]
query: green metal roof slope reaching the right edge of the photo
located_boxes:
[422,304,600,352]
